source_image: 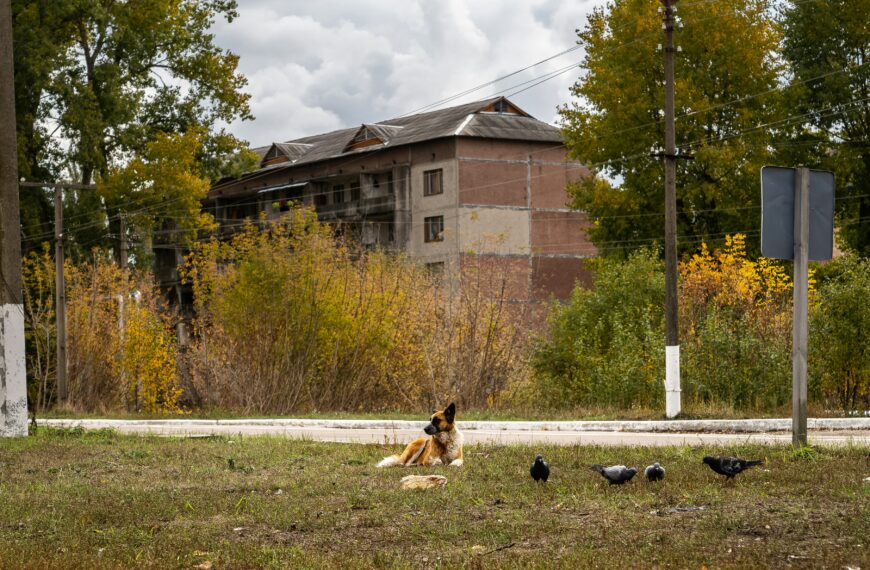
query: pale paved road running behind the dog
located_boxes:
[44,420,870,446]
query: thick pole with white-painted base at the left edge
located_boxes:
[0,0,27,437]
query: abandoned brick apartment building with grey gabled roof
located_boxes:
[166,97,596,303]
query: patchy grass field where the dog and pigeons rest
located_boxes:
[0,428,870,569]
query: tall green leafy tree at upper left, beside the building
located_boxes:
[13,0,251,260]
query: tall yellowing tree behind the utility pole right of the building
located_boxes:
[561,0,782,253]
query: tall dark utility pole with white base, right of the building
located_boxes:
[662,0,680,418]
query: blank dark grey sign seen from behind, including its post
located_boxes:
[761,166,834,446]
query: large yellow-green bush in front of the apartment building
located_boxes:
[185,207,524,413]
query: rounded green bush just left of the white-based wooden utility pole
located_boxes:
[532,250,664,407]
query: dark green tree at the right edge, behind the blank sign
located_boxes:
[783,0,870,257]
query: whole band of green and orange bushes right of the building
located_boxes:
[532,234,870,412]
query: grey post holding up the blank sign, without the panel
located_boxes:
[791,167,810,447]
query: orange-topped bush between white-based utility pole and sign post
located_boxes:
[679,234,792,409]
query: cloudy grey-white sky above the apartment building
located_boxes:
[214,0,604,146]
